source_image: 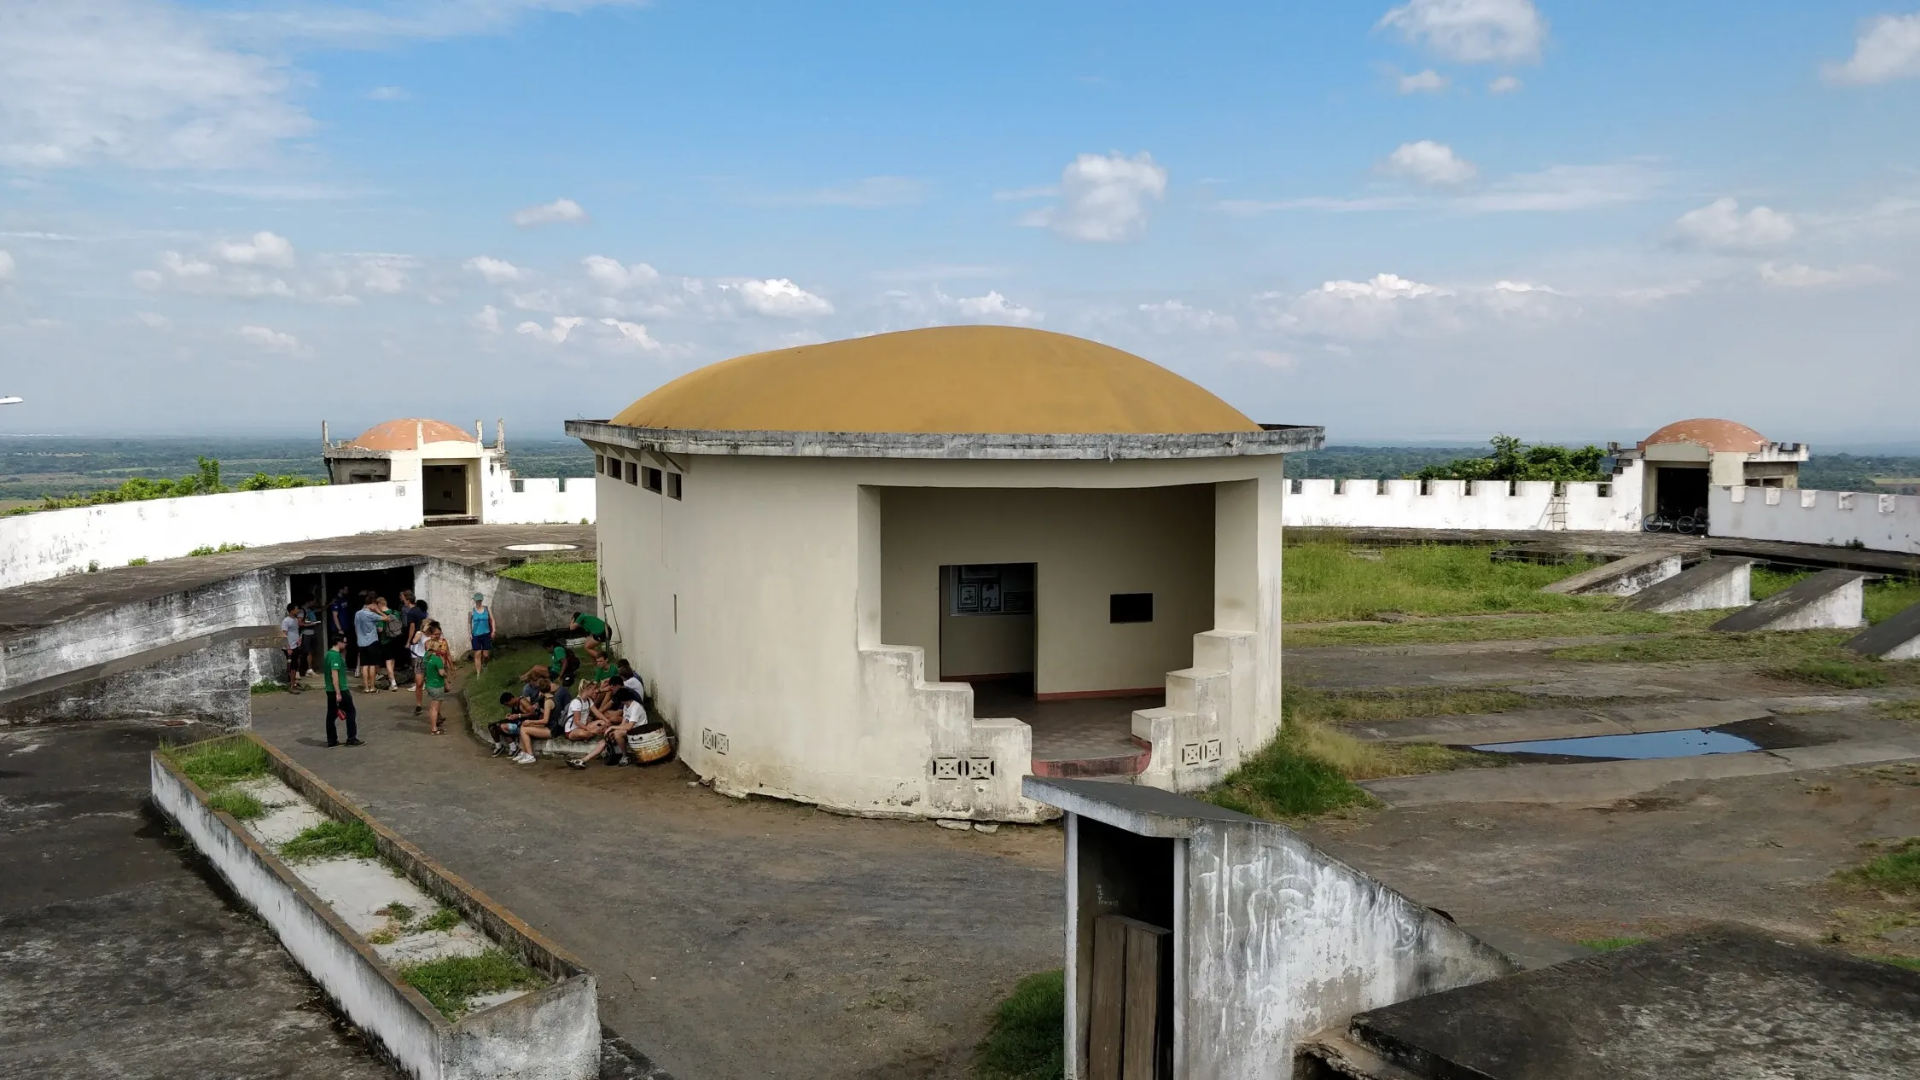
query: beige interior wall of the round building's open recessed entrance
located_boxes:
[881,484,1213,694]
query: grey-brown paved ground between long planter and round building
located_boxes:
[253,684,1062,1080]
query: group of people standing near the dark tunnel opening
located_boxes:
[299,586,493,746]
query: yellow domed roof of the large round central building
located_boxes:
[612,327,1260,434]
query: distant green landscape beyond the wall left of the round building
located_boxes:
[0,436,593,511]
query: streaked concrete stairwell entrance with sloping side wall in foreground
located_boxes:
[1023,776,1519,1080]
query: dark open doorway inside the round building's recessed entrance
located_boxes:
[939,563,1039,680]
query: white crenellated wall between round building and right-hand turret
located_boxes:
[1283,461,1642,532]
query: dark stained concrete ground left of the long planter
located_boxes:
[0,721,396,1080]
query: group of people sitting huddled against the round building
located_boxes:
[488,645,647,769]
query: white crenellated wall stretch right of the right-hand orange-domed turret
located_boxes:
[1707,486,1920,553]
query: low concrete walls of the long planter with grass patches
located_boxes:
[152,730,599,1080]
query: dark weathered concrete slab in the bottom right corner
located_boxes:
[1352,914,1920,1080]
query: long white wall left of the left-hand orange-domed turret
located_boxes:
[0,482,420,588]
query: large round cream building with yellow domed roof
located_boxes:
[566,327,1321,821]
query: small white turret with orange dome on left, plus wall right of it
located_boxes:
[321,417,595,525]
